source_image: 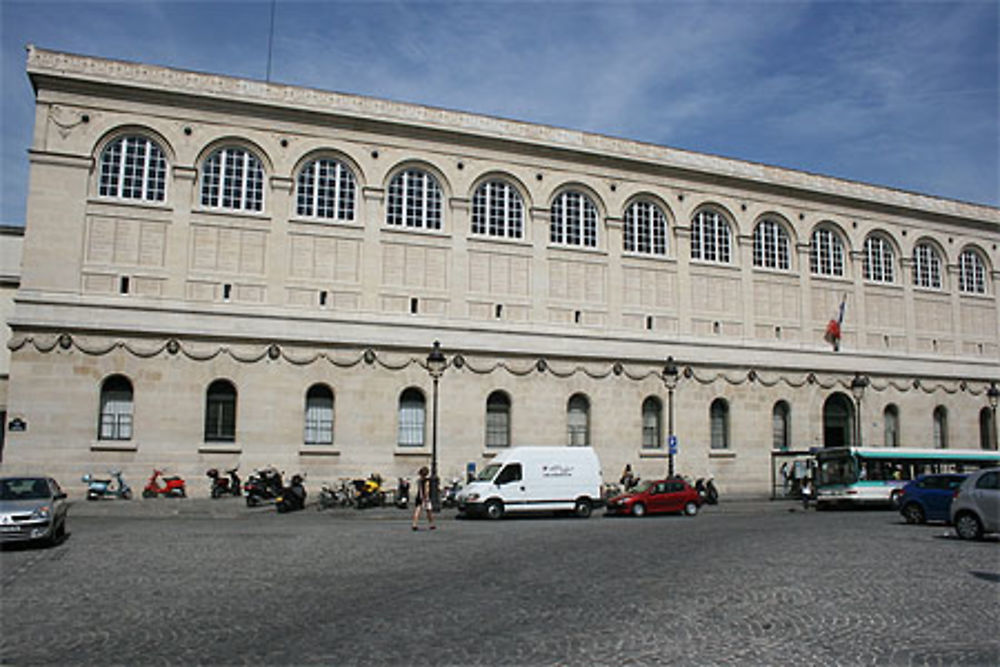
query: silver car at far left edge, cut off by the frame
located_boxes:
[0,477,67,544]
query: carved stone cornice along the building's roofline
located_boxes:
[27,45,1000,225]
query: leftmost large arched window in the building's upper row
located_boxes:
[98,136,167,201]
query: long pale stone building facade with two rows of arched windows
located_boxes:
[3,47,1000,493]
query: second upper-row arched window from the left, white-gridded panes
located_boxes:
[201,146,264,211]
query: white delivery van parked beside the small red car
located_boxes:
[457,447,602,519]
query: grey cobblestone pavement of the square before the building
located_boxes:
[0,499,1000,666]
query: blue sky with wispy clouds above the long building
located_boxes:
[0,0,1000,224]
